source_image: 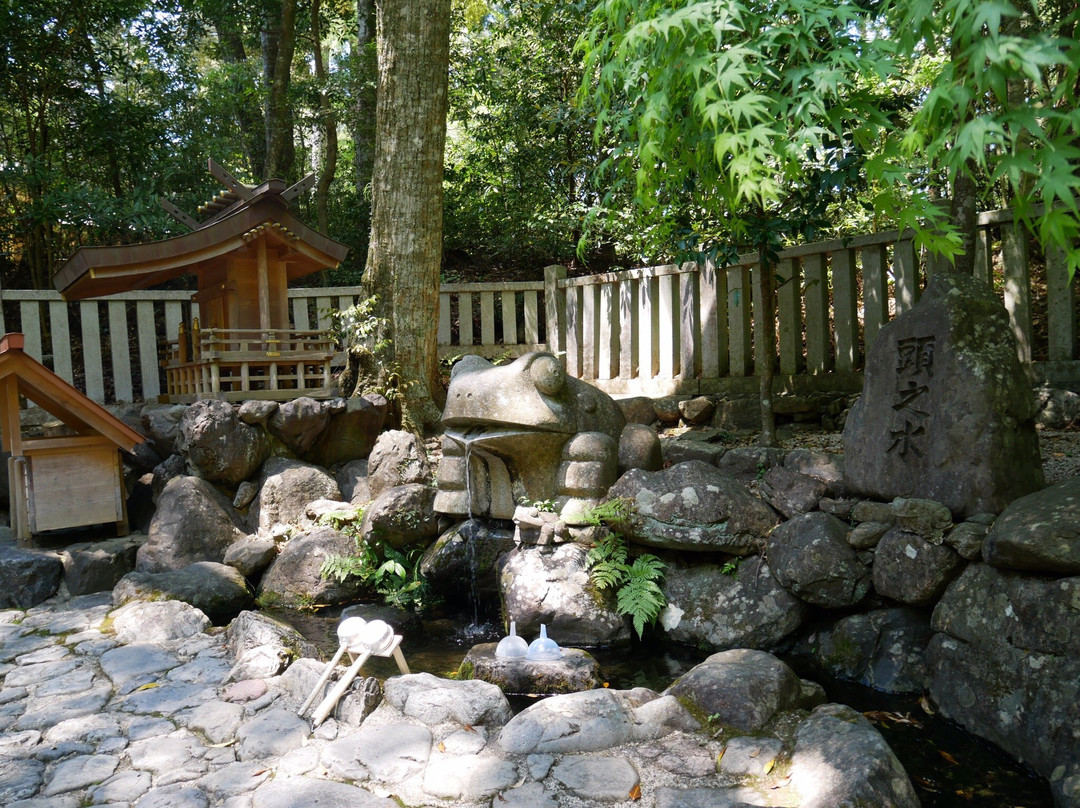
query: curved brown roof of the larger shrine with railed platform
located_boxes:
[53,179,349,300]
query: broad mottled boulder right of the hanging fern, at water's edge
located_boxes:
[658,557,807,650]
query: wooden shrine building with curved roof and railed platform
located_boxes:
[53,160,349,403]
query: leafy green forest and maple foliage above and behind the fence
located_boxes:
[6,0,1080,288]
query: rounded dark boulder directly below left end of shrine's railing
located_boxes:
[176,399,270,488]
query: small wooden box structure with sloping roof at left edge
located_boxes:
[0,334,146,542]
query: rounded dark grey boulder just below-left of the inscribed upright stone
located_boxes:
[768,512,870,609]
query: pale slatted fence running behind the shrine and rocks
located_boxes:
[0,203,1080,402]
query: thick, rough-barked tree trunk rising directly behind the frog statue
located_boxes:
[364,0,450,428]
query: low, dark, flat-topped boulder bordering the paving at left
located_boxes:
[112,561,254,625]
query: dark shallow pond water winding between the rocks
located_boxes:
[270,610,1053,808]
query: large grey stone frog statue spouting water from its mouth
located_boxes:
[435,352,659,524]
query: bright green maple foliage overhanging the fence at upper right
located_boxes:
[581,0,1080,273]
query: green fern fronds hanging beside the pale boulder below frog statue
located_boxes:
[586,533,666,637]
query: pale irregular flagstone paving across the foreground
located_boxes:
[0,593,917,808]
